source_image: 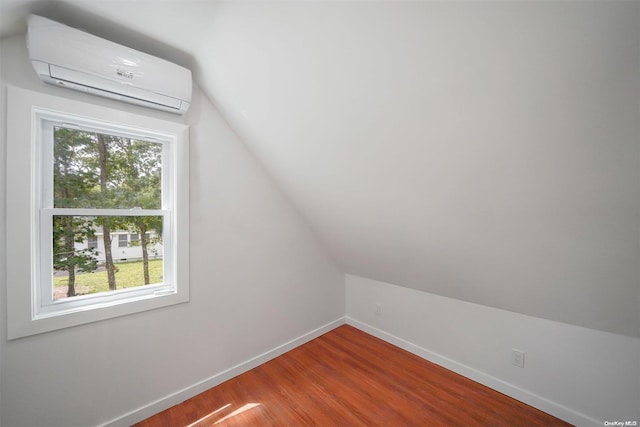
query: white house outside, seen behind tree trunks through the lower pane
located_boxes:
[76,231,163,263]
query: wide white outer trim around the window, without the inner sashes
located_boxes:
[6,85,189,339]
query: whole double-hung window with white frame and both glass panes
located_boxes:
[7,87,189,338]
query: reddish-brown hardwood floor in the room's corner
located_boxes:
[136,325,570,427]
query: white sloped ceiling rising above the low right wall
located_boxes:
[2,0,640,336]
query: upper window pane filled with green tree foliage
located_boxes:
[53,127,162,209]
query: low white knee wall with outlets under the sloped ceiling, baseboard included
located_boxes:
[346,275,640,426]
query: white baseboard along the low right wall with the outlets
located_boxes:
[345,316,602,427]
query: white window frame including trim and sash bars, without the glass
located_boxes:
[7,86,189,339]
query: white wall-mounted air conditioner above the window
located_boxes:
[27,15,192,114]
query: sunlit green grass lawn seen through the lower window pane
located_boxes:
[53,259,162,295]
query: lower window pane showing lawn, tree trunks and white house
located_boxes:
[52,215,163,300]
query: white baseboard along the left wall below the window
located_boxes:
[101,317,345,427]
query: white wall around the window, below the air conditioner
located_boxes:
[0,36,344,427]
